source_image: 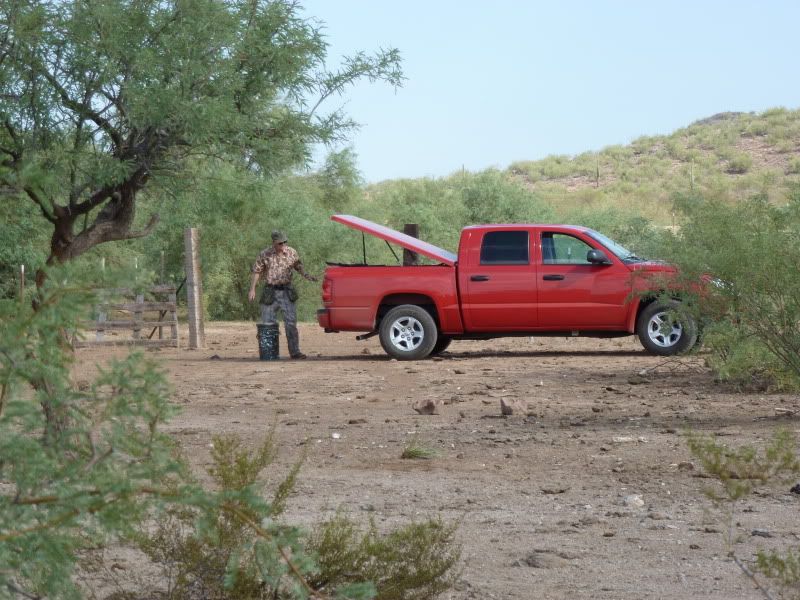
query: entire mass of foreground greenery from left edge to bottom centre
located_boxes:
[0,274,459,599]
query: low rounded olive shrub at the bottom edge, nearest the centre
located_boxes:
[309,514,461,600]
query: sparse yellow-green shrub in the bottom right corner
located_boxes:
[687,431,800,599]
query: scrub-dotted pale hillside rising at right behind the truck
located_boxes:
[507,108,800,224]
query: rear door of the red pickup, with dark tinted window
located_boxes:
[459,228,537,332]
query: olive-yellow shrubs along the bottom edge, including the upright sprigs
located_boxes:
[134,431,460,600]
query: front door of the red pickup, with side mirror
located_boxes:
[537,229,631,330]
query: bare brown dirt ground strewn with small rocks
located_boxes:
[78,323,800,600]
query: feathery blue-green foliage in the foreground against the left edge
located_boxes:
[0,269,188,598]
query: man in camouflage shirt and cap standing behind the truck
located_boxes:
[247,231,317,358]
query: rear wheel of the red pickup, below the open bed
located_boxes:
[378,304,439,360]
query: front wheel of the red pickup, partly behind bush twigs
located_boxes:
[636,300,698,356]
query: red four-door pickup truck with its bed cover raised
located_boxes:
[317,215,698,360]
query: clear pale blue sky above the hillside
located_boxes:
[301,0,800,182]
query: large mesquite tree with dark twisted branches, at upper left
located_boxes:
[0,0,403,283]
